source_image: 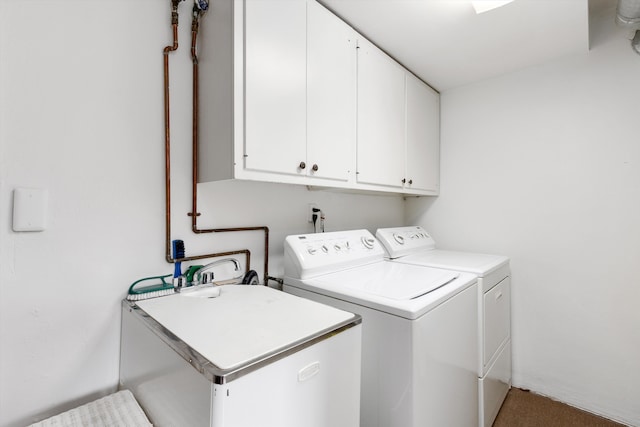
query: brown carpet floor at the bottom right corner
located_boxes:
[493,387,624,427]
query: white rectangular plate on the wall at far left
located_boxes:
[13,188,48,231]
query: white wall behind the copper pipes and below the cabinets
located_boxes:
[0,0,403,427]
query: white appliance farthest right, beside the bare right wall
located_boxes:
[376,226,511,427]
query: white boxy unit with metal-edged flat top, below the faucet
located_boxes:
[120,285,361,427]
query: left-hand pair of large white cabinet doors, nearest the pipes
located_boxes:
[244,0,356,181]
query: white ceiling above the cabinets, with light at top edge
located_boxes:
[319,0,596,91]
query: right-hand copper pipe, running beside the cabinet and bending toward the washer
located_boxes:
[188,0,281,285]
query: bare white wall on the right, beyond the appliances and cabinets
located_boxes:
[406,2,640,426]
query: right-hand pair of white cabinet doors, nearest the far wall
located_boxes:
[357,40,440,194]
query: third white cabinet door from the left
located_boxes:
[357,39,405,187]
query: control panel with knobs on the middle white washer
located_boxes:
[284,230,384,279]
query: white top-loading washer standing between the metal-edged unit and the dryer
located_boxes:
[283,230,478,427]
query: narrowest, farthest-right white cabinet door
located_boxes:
[405,74,440,192]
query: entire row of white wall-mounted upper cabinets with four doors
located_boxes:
[198,0,439,195]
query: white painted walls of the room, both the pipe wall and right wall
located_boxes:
[0,0,640,427]
